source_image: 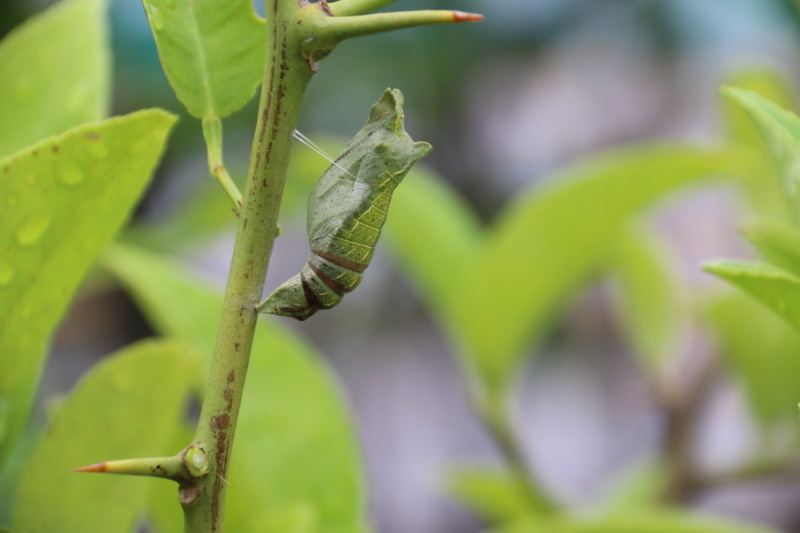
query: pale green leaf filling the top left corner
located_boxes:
[0,0,110,157]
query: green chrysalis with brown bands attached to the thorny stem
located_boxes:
[258,89,431,320]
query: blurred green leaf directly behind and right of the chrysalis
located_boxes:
[386,167,483,319]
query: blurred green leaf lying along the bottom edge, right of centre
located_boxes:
[493,511,777,533]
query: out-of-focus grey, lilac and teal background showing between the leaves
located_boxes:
[0,0,800,533]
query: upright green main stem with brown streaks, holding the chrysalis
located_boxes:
[181,0,312,533]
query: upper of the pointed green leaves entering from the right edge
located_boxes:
[723,87,800,218]
